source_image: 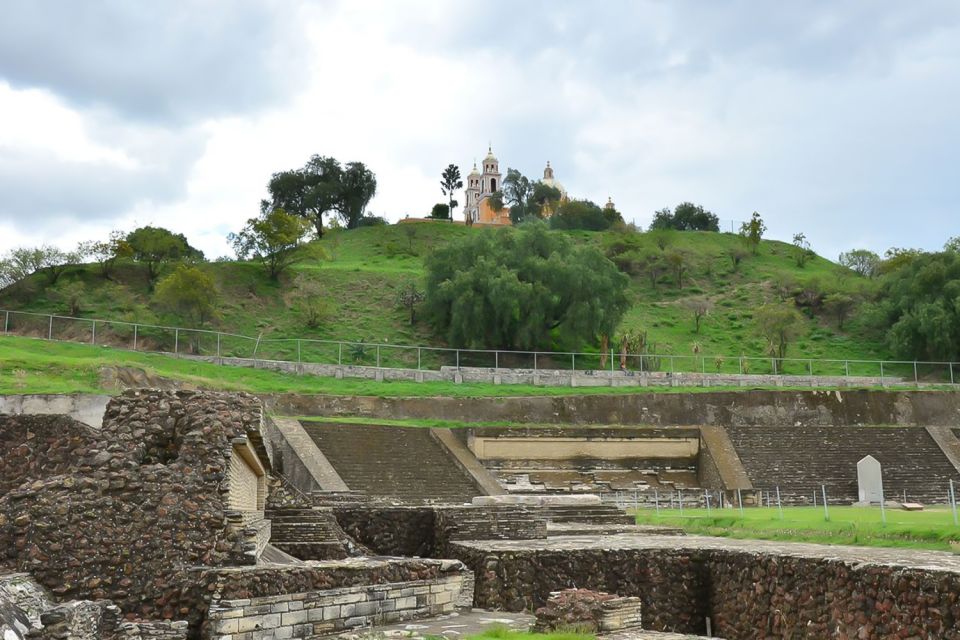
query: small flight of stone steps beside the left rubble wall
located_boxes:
[266,507,351,560]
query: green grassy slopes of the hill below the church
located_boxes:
[0,223,888,370]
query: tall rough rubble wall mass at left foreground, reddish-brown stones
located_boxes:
[0,391,270,619]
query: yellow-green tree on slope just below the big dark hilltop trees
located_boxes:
[227,208,309,280]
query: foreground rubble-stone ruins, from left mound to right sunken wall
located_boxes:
[0,390,960,640]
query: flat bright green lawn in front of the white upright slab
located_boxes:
[637,506,960,551]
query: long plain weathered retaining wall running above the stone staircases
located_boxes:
[262,390,960,427]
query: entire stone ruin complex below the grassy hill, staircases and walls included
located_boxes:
[0,389,960,640]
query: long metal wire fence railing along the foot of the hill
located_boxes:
[0,309,960,385]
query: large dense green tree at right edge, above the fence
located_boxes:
[880,251,960,361]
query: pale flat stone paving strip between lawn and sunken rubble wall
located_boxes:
[456,533,960,574]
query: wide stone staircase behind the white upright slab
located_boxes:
[726,426,960,504]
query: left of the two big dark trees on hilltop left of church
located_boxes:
[261,155,343,238]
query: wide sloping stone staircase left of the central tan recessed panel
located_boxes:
[303,422,483,504]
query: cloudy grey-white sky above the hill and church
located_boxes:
[0,0,960,259]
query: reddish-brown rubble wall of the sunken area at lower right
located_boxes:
[451,543,960,640]
